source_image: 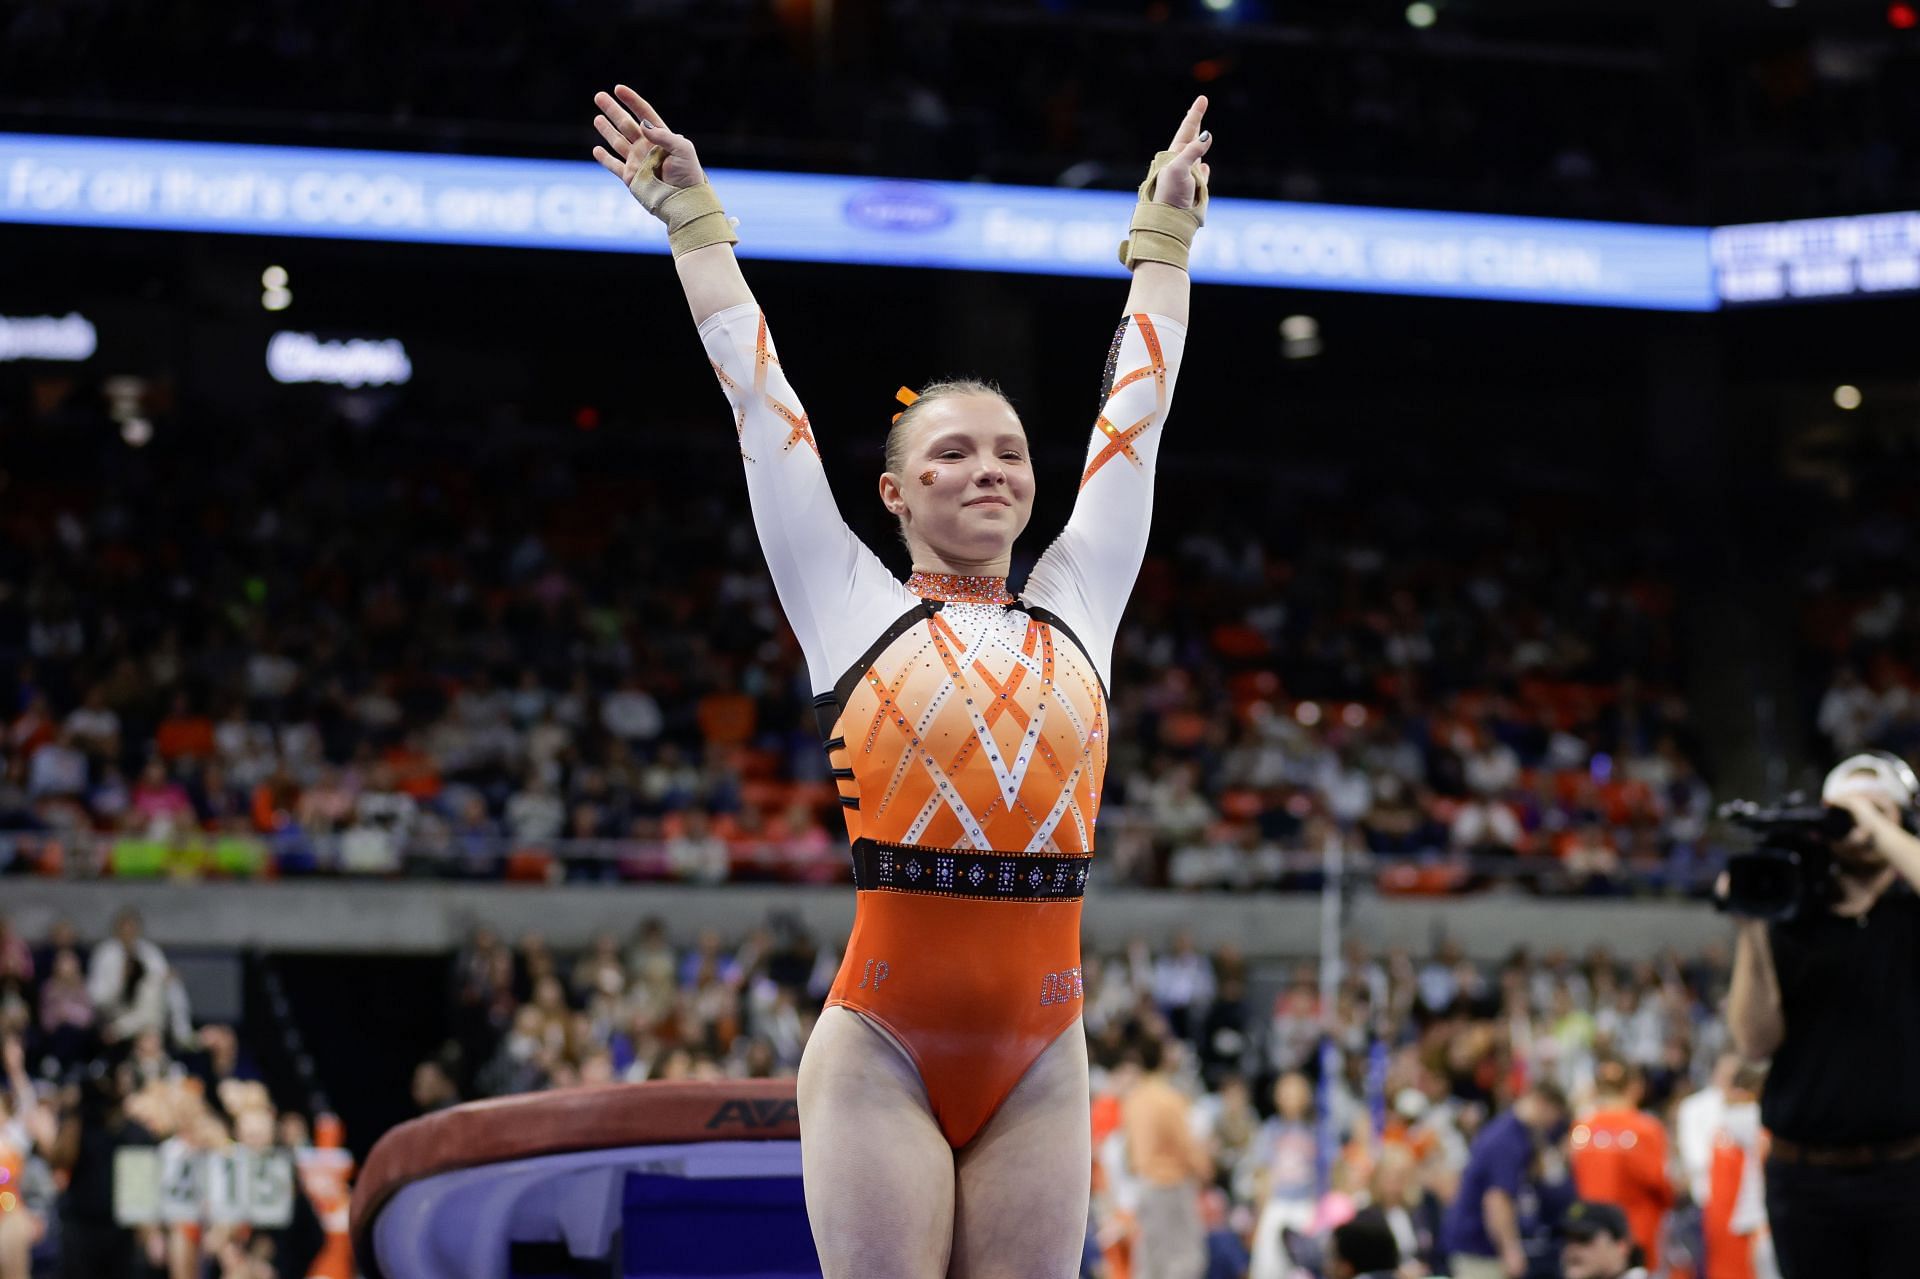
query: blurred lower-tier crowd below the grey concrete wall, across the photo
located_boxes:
[0,912,1757,1279]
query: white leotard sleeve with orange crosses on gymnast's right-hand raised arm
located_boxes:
[1021,315,1187,680]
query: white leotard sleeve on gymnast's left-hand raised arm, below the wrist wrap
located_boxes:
[701,302,918,693]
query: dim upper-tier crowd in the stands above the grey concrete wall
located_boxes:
[0,422,1711,893]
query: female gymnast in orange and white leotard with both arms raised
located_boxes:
[593,84,1212,1279]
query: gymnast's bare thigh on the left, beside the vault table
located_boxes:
[799,1008,954,1279]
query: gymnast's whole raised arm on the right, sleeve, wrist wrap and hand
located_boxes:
[1025,98,1213,678]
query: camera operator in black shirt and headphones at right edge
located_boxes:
[1728,755,1920,1279]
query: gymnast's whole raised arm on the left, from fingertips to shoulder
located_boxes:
[593,84,914,691]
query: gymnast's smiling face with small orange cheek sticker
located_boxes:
[879,396,1033,564]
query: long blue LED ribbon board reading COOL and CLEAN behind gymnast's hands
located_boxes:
[0,134,1718,311]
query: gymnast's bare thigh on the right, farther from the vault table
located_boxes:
[948,1022,1092,1279]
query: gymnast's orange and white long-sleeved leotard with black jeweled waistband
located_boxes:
[701,303,1187,1148]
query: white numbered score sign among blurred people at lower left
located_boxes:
[113,1141,300,1231]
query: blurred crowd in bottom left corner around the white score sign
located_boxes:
[0,910,353,1279]
